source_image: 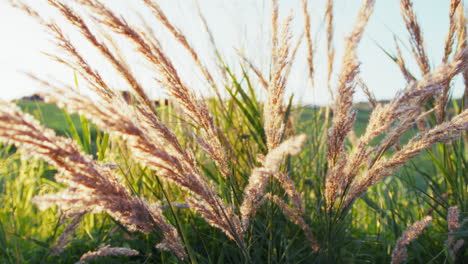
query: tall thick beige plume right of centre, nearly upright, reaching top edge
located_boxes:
[325,0,375,208]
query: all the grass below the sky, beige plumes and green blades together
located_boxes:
[0,0,468,263]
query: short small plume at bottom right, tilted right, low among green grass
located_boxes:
[391,216,432,264]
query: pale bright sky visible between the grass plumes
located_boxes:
[0,0,463,105]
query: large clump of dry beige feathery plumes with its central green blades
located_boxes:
[0,0,468,263]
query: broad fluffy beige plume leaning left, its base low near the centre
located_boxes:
[41,89,242,245]
